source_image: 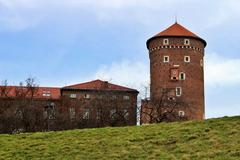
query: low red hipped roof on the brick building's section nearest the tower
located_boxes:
[63,79,138,92]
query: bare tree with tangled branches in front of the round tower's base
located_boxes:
[141,88,191,123]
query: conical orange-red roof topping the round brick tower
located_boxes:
[147,22,207,46]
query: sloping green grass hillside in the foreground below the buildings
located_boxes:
[0,117,240,160]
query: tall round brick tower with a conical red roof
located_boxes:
[147,23,207,120]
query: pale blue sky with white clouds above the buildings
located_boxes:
[0,0,240,118]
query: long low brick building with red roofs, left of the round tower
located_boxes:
[0,80,138,133]
